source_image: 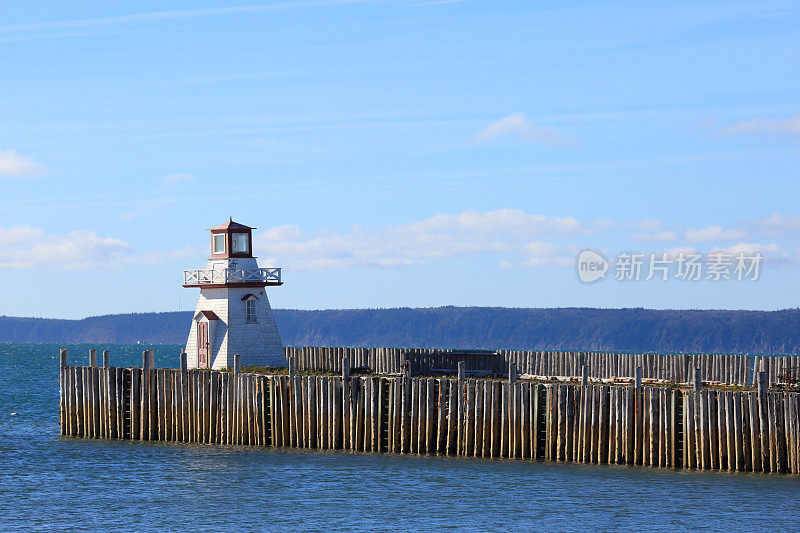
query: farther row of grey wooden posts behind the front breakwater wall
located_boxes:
[286,346,800,386]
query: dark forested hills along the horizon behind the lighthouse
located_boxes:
[0,307,800,354]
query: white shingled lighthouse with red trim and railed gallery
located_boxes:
[183,219,287,369]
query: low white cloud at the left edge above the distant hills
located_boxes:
[0,226,132,270]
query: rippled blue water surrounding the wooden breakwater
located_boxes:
[0,344,800,531]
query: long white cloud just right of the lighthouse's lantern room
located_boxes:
[255,209,585,270]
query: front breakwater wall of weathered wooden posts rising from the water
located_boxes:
[60,350,800,475]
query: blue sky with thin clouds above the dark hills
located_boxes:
[0,0,800,318]
